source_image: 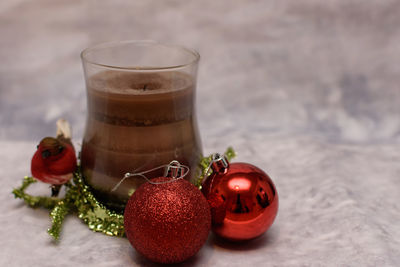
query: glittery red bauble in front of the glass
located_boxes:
[124,177,211,263]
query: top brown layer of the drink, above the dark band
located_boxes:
[88,71,193,126]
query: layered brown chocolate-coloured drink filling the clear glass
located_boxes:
[81,70,201,210]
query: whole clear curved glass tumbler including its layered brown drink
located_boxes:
[81,41,202,211]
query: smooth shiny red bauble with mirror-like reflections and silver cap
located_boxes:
[201,154,278,241]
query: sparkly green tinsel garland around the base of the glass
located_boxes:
[12,147,236,240]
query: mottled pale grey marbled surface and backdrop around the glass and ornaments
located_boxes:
[0,0,400,266]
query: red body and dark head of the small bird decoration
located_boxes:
[31,137,77,185]
